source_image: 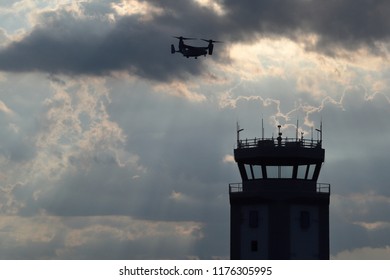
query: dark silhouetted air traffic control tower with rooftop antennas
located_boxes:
[229,124,330,260]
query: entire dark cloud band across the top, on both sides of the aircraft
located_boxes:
[0,0,390,81]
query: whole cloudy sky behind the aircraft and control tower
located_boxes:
[0,0,390,259]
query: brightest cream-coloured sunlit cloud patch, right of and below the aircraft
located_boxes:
[226,36,388,99]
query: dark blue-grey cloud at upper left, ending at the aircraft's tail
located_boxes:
[0,10,204,80]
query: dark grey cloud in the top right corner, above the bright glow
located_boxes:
[224,0,390,54]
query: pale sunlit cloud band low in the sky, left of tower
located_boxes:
[0,214,203,259]
